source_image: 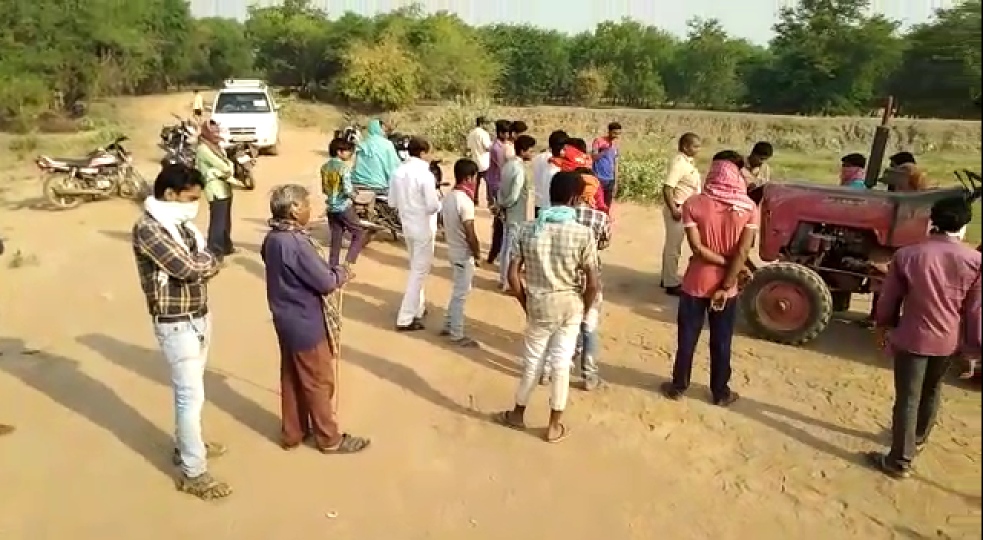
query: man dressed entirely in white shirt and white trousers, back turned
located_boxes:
[389,137,440,332]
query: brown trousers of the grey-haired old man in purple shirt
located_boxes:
[280,340,341,448]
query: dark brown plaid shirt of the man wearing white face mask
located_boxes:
[133,214,218,317]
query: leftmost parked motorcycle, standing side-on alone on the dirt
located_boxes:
[35,135,150,210]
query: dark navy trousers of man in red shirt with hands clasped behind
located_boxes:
[672,293,737,400]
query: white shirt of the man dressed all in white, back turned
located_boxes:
[389,156,440,239]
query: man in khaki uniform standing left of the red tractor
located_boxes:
[661,133,703,296]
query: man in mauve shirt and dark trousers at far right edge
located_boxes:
[867,197,981,478]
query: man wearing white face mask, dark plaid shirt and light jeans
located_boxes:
[133,164,232,500]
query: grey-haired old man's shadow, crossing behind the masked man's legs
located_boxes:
[78,334,280,444]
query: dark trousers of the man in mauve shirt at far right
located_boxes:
[888,352,949,468]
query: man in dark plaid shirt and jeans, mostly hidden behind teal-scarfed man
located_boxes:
[539,177,611,392]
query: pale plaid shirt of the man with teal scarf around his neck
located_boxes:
[510,221,597,322]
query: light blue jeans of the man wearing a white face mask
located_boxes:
[154,315,212,478]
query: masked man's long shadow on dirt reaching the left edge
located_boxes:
[0,338,175,477]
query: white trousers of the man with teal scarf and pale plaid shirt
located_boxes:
[515,303,583,411]
